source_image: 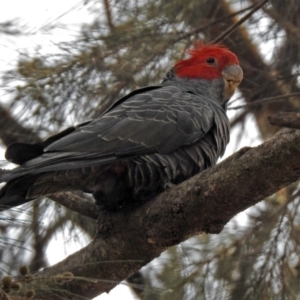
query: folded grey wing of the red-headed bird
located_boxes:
[1,86,215,175]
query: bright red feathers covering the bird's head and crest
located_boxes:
[174,42,239,80]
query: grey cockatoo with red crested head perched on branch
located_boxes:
[0,42,243,211]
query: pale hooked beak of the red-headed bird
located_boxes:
[222,65,243,100]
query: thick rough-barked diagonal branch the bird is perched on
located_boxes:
[10,130,300,299]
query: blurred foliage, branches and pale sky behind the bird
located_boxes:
[0,0,300,300]
